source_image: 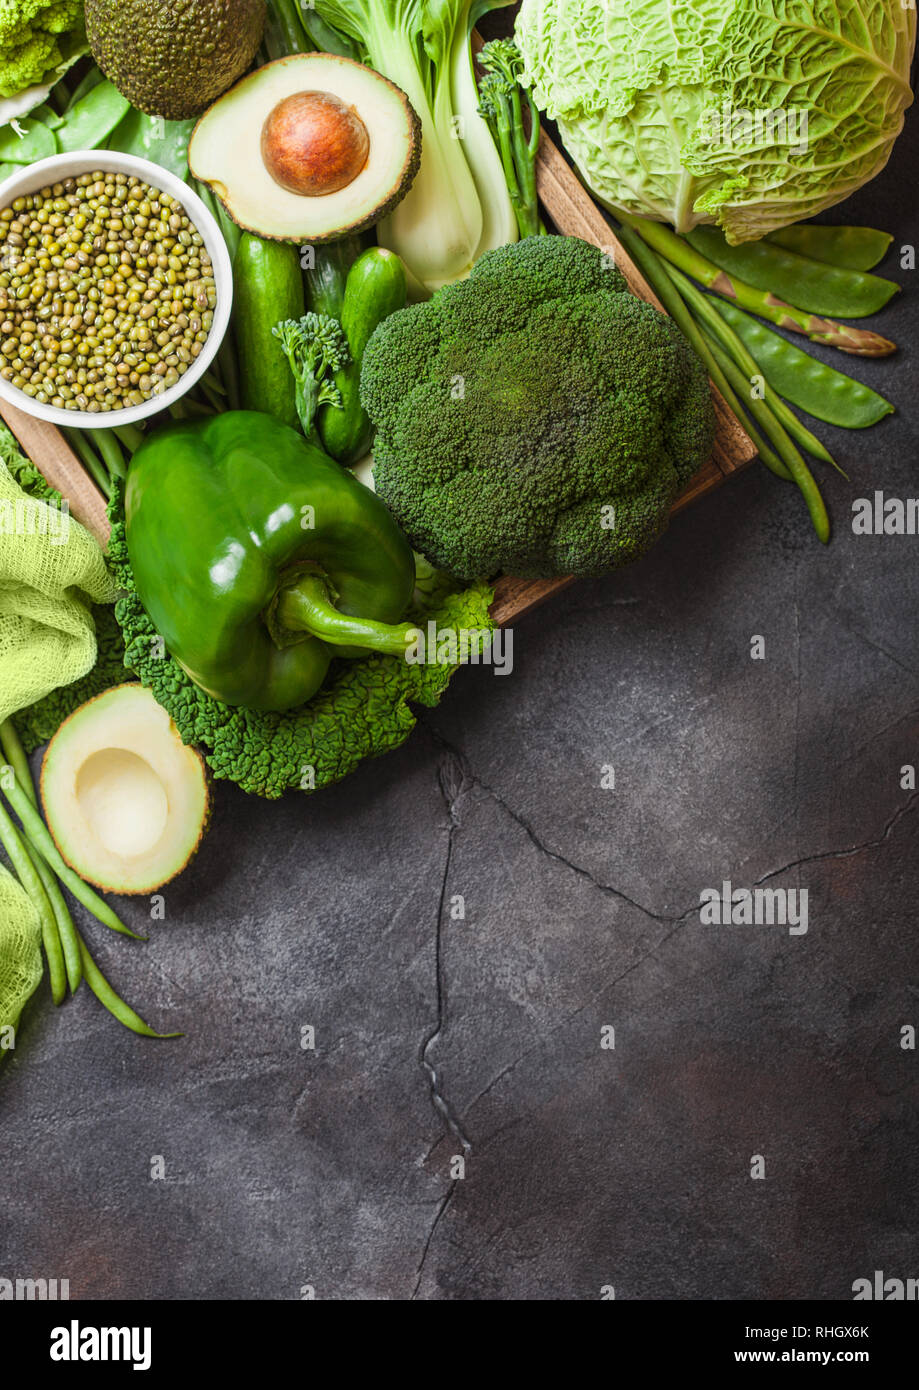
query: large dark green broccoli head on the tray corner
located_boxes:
[360,236,715,582]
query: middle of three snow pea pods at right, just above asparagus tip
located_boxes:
[685,227,900,318]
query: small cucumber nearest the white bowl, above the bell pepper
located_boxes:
[234,232,306,430]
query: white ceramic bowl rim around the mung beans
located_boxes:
[0,150,234,430]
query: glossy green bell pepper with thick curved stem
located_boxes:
[125,410,416,710]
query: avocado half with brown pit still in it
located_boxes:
[188,53,421,243]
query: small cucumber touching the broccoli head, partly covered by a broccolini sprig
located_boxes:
[318,246,406,466]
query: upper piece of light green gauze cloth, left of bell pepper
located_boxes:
[0,463,115,728]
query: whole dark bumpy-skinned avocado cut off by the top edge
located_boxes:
[85,0,267,121]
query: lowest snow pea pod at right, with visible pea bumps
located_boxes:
[713,299,894,430]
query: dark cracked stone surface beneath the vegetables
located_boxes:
[0,40,919,1300]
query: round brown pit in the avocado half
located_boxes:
[261,92,370,197]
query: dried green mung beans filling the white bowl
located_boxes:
[0,171,217,414]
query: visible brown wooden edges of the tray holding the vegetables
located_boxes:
[0,132,756,626]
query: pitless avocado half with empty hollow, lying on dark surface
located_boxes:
[42,685,210,894]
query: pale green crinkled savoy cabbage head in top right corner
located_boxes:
[517,0,916,243]
